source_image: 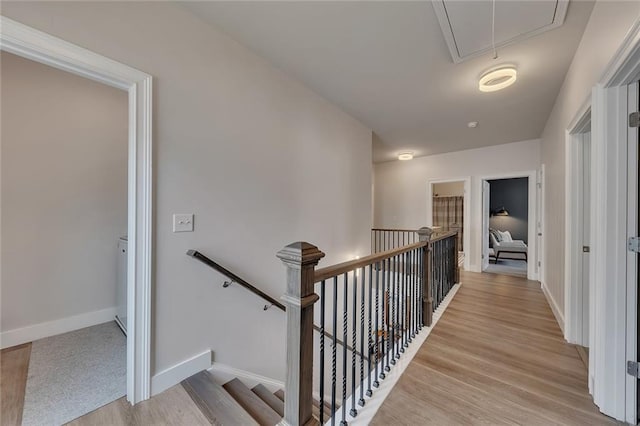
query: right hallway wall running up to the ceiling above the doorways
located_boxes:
[542,1,640,313]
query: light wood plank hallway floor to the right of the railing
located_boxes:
[372,273,616,425]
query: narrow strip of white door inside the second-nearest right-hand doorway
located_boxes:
[578,132,591,347]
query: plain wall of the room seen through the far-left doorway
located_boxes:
[0,52,128,334]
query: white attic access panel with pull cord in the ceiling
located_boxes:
[432,0,569,63]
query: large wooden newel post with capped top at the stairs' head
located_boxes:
[277,242,324,426]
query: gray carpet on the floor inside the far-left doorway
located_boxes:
[22,322,127,426]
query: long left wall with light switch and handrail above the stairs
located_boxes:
[2,2,372,379]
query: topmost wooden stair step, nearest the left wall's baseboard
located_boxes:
[182,371,258,425]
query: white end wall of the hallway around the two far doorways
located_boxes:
[374,140,540,270]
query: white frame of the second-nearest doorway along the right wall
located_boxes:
[564,104,595,346]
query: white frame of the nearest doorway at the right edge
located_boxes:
[589,20,640,424]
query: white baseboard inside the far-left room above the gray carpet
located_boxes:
[0,307,117,349]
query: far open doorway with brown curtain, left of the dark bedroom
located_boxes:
[427,177,471,270]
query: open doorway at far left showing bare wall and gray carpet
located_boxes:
[0,52,129,424]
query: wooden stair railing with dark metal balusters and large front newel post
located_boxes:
[278,228,459,425]
